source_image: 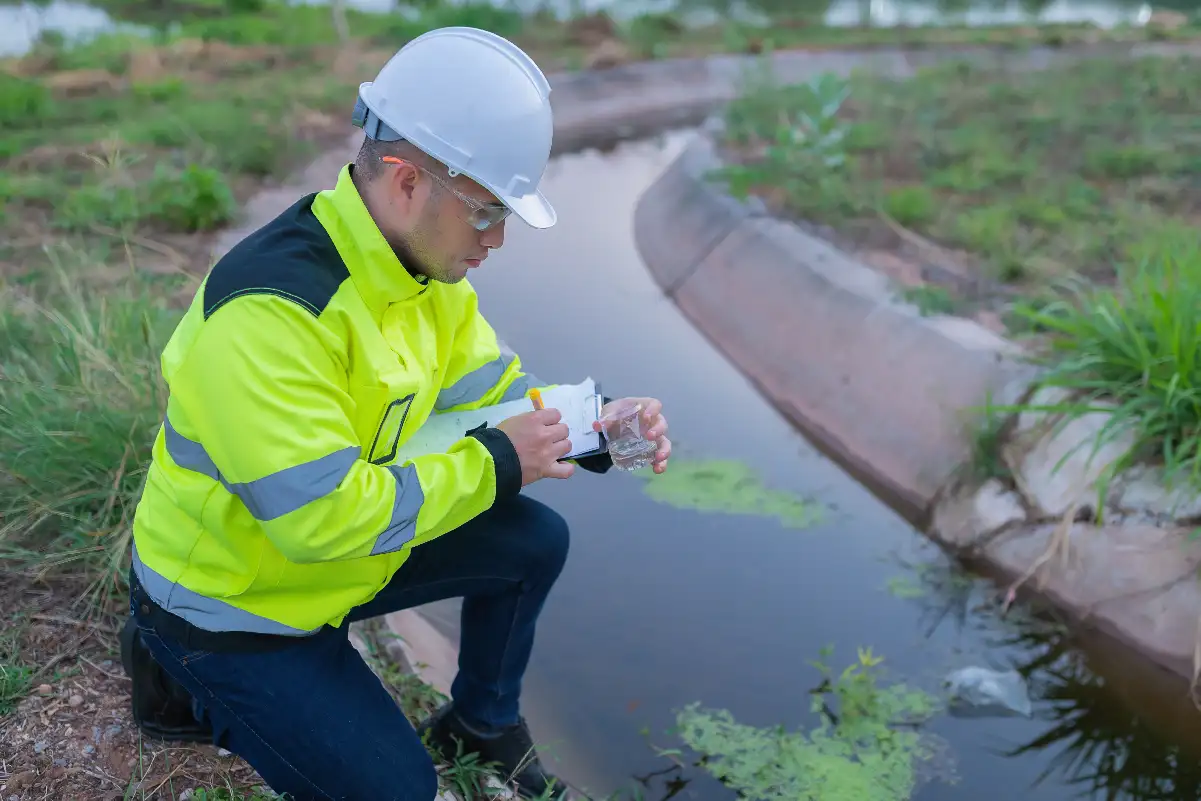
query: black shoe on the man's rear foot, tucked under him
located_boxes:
[120,617,213,743]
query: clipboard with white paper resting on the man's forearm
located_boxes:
[395,377,609,464]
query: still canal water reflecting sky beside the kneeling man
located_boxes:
[428,132,1201,801]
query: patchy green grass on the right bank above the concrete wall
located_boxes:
[710,51,1201,310]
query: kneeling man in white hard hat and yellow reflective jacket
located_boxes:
[123,28,670,801]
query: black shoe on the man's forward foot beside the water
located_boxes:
[417,704,567,801]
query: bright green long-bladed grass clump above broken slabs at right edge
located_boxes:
[1015,232,1201,494]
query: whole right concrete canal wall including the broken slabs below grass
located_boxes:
[634,54,1201,681]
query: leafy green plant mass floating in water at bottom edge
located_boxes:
[677,648,942,801]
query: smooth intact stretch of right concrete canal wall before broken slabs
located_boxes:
[634,136,1033,525]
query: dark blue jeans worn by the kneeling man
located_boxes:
[131,496,568,801]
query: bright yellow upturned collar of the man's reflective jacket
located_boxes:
[312,165,429,313]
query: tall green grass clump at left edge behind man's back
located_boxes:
[0,266,178,605]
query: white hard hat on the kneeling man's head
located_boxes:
[354,26,557,228]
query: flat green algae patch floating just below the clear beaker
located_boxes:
[631,458,821,528]
